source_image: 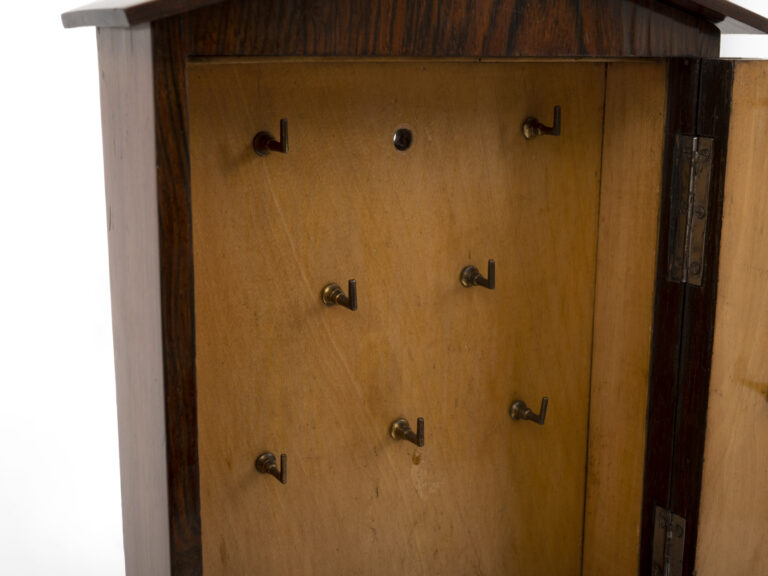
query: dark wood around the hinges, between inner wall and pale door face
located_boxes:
[640,60,733,576]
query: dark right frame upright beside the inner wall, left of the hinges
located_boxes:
[640,60,700,575]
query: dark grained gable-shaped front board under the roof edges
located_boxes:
[182,0,720,58]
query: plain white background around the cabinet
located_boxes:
[0,0,768,576]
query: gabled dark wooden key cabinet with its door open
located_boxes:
[63,0,768,576]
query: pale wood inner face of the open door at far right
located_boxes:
[696,62,768,576]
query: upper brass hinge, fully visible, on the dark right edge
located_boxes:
[668,134,713,286]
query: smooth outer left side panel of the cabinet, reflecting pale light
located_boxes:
[98,26,170,576]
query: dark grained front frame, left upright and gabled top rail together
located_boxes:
[140,0,718,574]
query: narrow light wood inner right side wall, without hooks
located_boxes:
[583,62,666,576]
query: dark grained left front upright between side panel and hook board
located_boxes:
[152,19,202,575]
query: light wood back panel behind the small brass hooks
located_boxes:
[188,61,605,576]
